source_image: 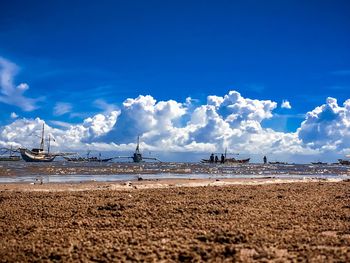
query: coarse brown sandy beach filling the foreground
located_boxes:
[0,180,350,262]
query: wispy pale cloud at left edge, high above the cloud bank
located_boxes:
[0,57,40,111]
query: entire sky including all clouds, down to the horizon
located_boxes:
[0,0,350,161]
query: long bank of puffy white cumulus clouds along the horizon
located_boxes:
[0,91,350,163]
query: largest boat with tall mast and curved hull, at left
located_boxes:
[19,124,60,162]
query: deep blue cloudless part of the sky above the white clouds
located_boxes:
[0,0,350,162]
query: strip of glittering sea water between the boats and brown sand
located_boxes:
[0,161,350,184]
